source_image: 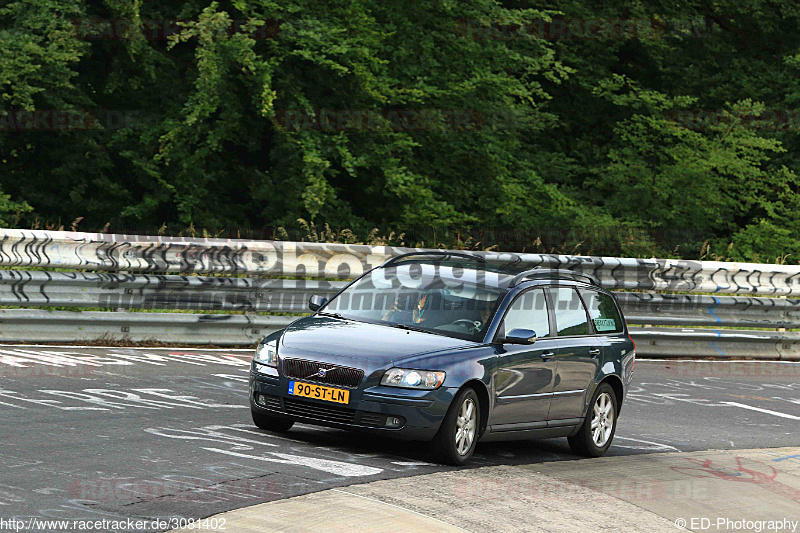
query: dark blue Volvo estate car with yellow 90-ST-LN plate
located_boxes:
[250,252,635,465]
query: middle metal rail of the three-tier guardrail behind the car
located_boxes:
[6,270,800,329]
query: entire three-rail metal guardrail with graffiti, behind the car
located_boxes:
[0,230,800,360]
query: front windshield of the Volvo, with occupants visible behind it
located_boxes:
[320,263,506,341]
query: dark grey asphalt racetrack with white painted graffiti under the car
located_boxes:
[0,346,800,531]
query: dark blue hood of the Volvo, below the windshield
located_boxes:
[278,316,476,371]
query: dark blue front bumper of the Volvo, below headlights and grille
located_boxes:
[250,367,458,440]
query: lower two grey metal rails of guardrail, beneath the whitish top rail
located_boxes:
[0,270,800,359]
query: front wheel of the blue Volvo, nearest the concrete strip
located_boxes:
[431,388,481,466]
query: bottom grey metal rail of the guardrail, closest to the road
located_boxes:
[0,309,800,361]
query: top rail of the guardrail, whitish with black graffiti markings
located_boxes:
[0,230,800,296]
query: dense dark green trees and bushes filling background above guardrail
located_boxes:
[0,0,800,263]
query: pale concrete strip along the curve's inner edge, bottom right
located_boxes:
[191,447,800,533]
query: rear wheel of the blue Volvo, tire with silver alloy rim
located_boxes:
[567,383,619,457]
